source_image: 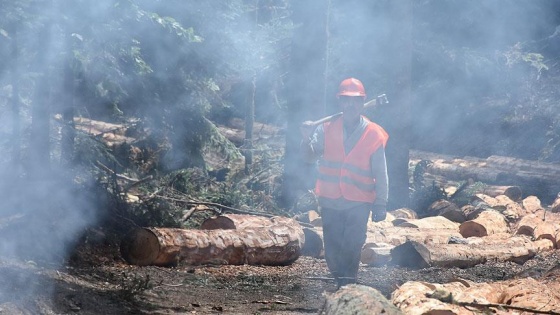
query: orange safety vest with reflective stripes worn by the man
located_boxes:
[315,116,389,203]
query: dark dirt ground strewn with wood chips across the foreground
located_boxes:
[0,237,559,314]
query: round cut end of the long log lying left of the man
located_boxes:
[120,229,160,266]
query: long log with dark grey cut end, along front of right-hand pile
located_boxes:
[391,235,554,268]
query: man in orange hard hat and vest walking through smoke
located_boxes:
[301,78,389,288]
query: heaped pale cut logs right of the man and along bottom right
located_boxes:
[308,190,560,314]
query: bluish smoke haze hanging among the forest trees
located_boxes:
[0,0,560,304]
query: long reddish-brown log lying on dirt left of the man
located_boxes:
[121,224,304,266]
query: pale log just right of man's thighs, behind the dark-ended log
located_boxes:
[366,226,461,246]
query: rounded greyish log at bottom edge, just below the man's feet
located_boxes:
[321,284,403,315]
